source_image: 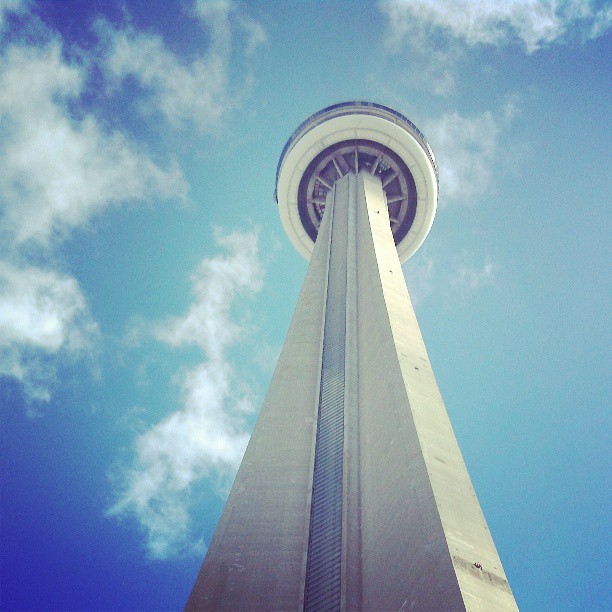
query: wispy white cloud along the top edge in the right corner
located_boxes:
[379,0,612,95]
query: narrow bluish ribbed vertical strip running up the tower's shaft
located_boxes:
[304,179,347,612]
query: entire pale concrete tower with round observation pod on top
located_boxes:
[187,102,517,611]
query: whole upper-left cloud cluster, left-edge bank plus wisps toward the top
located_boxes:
[0,0,265,401]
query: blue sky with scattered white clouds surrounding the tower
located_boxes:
[0,0,612,610]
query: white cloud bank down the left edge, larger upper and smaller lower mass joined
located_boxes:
[0,40,185,401]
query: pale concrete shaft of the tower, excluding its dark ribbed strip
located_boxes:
[187,172,517,611]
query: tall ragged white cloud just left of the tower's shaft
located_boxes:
[109,232,262,558]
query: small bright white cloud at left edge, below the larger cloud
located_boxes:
[0,261,98,402]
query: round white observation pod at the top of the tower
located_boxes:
[275,102,438,262]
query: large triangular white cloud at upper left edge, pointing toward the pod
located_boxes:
[0,42,185,244]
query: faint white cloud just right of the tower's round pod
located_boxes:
[424,103,516,204]
